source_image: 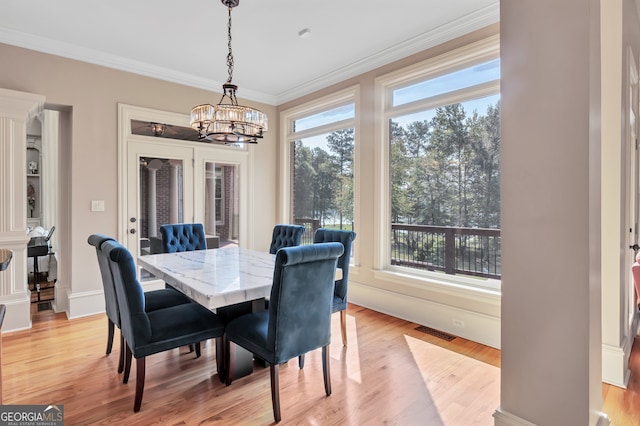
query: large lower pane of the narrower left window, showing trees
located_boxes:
[291,128,354,243]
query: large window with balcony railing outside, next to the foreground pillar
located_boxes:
[378,36,501,287]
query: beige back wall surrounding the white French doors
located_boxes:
[0,44,277,315]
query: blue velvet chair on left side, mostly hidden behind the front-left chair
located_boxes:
[88,234,199,373]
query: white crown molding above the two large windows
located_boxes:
[276,2,500,105]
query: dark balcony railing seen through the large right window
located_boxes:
[391,223,501,279]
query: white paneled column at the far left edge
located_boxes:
[0,89,45,331]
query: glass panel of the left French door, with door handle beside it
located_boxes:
[138,157,184,255]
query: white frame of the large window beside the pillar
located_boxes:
[373,35,501,291]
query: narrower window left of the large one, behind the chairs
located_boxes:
[283,89,357,243]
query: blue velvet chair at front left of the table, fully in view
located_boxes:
[102,241,224,412]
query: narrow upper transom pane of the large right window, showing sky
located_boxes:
[393,59,500,106]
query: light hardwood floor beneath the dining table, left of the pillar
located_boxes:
[2,305,500,426]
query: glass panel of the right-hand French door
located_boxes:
[204,161,240,248]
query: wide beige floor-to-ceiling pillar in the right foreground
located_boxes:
[495,0,608,426]
